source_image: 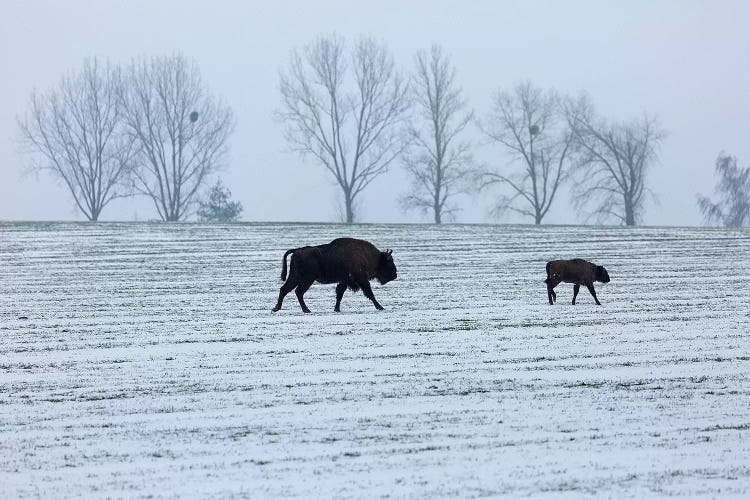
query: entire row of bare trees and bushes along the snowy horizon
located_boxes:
[19,35,750,226]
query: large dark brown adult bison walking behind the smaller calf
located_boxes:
[272,238,396,313]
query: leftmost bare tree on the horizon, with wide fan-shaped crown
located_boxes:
[18,59,134,221]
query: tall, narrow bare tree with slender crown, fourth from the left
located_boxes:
[401,45,473,224]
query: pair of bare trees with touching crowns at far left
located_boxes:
[18,55,239,221]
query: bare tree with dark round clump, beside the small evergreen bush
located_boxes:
[122,55,234,221]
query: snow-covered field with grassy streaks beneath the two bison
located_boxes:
[0,223,750,498]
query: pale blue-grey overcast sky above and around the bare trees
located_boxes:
[0,0,750,225]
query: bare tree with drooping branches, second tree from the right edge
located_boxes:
[567,96,666,226]
